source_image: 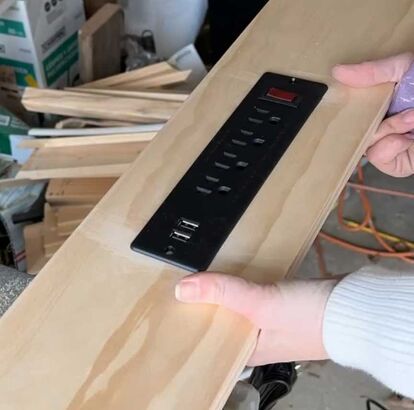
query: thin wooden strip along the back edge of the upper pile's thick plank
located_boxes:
[65,87,189,102]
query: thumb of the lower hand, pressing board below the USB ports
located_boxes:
[175,273,277,327]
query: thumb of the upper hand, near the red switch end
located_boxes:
[332,53,414,87]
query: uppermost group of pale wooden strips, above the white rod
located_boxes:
[23,62,191,123]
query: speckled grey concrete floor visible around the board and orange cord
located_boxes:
[0,166,414,410]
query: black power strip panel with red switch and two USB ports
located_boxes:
[131,73,328,271]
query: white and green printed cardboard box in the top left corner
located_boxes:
[0,0,85,88]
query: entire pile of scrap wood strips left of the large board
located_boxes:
[17,62,190,274]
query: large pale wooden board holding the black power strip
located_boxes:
[0,0,414,410]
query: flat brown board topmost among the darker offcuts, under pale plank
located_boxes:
[46,178,116,206]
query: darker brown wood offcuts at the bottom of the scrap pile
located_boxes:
[24,178,116,274]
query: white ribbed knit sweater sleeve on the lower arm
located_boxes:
[323,267,414,398]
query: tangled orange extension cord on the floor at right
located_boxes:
[314,164,414,276]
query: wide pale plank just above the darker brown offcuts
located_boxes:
[16,142,147,179]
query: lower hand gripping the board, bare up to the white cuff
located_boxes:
[176,273,337,366]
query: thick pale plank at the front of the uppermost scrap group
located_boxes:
[22,87,181,122]
